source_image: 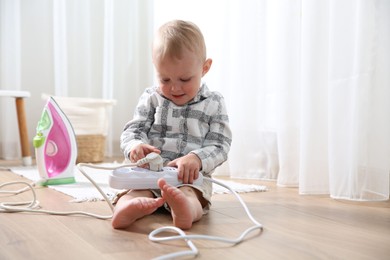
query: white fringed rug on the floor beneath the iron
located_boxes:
[9,163,267,202]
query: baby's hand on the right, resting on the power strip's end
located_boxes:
[168,153,202,184]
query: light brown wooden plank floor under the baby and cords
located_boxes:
[0,161,390,260]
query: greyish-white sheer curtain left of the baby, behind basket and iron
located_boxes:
[0,0,153,159]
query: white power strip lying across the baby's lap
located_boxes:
[108,167,203,190]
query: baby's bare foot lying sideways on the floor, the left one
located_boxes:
[111,197,164,228]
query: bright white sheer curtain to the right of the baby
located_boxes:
[155,0,390,200]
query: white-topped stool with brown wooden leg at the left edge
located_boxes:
[0,90,32,166]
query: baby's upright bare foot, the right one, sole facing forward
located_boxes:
[158,179,203,229]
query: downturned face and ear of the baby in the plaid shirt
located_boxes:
[154,50,211,106]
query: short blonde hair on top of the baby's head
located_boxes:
[152,20,206,62]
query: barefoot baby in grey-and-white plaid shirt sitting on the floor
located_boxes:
[112,20,232,229]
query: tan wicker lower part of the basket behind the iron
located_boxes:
[76,135,106,163]
